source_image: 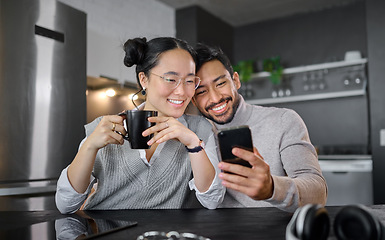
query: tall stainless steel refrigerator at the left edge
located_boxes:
[0,0,86,210]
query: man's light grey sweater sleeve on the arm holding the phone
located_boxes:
[267,110,327,212]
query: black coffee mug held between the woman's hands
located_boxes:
[118,110,158,149]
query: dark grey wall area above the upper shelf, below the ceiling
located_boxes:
[234,1,367,70]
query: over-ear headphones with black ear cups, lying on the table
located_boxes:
[286,204,385,240]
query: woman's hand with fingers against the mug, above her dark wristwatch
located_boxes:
[142,117,199,148]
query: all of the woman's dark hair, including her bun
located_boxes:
[123,37,196,86]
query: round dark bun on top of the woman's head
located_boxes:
[123,37,147,67]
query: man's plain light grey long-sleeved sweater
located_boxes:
[216,96,327,212]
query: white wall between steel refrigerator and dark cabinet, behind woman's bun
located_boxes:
[59,0,176,83]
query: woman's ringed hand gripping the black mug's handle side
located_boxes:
[86,115,126,150]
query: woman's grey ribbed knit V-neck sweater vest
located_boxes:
[84,115,212,209]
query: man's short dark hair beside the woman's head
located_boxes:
[195,43,234,78]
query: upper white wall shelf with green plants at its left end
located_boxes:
[251,58,368,79]
